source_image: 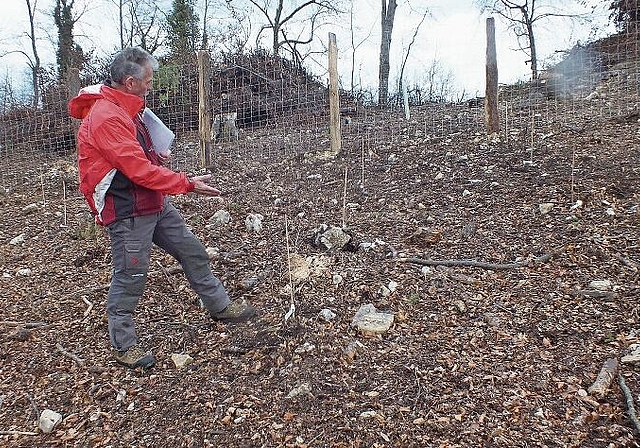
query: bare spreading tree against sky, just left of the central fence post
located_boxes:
[244,0,340,59]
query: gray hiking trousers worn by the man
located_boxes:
[107,199,229,351]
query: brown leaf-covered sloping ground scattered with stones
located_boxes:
[0,93,640,447]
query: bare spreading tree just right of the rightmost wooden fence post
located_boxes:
[476,0,584,79]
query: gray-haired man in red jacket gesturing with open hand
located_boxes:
[69,47,255,368]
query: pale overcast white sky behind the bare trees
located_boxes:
[0,0,613,97]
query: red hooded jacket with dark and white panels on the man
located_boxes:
[69,85,194,226]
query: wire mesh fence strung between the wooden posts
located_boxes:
[0,31,640,205]
